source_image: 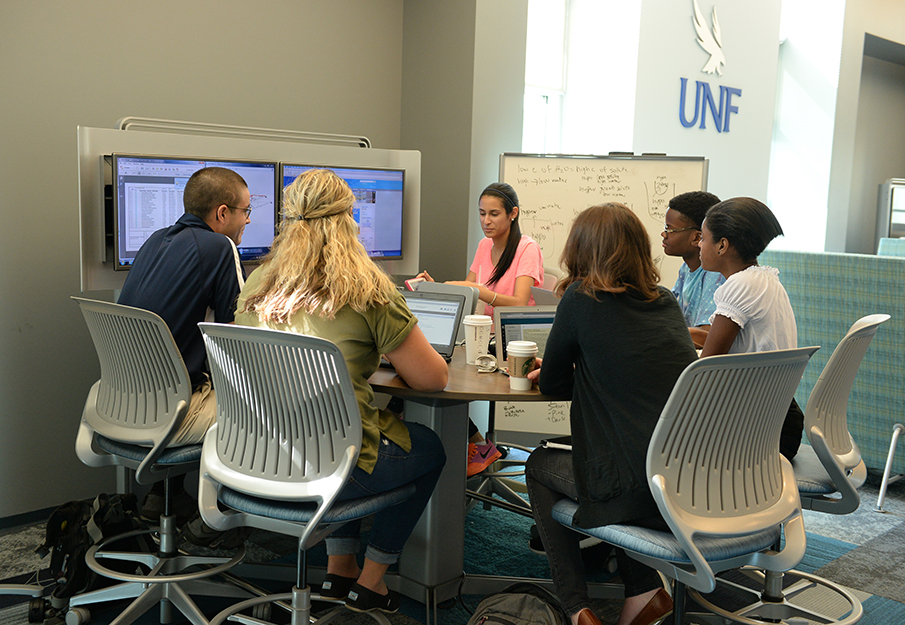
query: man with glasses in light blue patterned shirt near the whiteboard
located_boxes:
[662,191,725,348]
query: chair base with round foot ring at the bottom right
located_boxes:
[685,567,864,625]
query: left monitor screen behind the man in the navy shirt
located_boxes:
[113,154,277,269]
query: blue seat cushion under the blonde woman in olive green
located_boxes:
[218,484,415,523]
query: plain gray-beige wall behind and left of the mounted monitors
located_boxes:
[0,0,406,517]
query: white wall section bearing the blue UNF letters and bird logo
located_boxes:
[634,0,781,205]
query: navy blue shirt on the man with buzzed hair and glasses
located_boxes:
[119,213,245,386]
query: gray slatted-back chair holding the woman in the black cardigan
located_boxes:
[554,347,860,624]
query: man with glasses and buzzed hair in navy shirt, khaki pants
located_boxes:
[119,167,251,546]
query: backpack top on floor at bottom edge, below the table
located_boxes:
[468,582,569,625]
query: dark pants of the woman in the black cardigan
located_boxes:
[525,447,668,615]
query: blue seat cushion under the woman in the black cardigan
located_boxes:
[553,499,780,563]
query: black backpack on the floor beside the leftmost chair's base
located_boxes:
[35,493,153,599]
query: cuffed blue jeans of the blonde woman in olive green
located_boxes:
[327,423,446,564]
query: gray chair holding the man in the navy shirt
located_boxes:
[66,297,249,625]
